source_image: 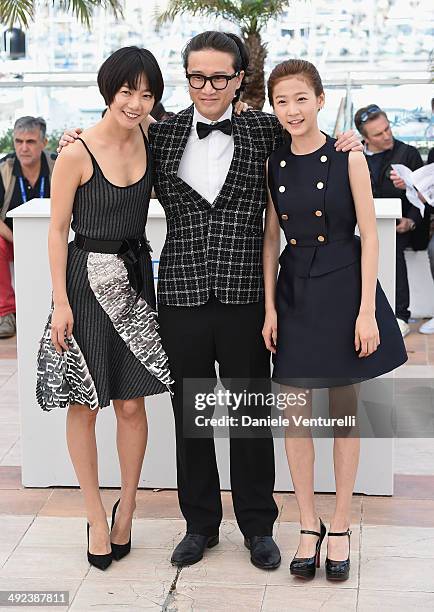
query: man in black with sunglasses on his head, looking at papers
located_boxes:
[354,104,428,337]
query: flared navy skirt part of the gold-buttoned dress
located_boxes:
[273,261,407,388]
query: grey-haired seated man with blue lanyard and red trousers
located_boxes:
[0,117,56,338]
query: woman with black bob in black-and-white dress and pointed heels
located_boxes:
[37,47,172,570]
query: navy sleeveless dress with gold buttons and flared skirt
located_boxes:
[268,136,407,388]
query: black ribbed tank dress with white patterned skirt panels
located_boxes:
[36,126,172,410]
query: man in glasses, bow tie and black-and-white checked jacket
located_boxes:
[149,32,362,569]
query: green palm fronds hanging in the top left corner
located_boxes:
[0,0,122,28]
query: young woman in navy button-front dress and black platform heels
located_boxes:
[263,60,407,580]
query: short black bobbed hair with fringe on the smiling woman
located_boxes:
[98,46,164,106]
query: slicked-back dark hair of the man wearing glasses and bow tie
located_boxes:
[182,30,250,97]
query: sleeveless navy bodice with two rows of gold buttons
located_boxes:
[268,136,360,277]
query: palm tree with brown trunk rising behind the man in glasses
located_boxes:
[157,0,289,109]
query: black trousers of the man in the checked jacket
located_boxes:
[159,296,278,537]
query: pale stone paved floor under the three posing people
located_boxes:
[0,325,434,612]
